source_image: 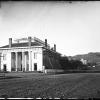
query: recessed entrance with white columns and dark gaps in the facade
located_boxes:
[11,51,28,71]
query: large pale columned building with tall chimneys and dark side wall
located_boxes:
[0,37,61,72]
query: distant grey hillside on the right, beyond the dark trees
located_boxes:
[72,52,100,63]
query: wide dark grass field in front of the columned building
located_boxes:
[0,73,100,98]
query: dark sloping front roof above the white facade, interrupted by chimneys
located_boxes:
[0,42,42,48]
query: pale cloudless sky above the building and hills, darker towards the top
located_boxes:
[0,1,100,56]
